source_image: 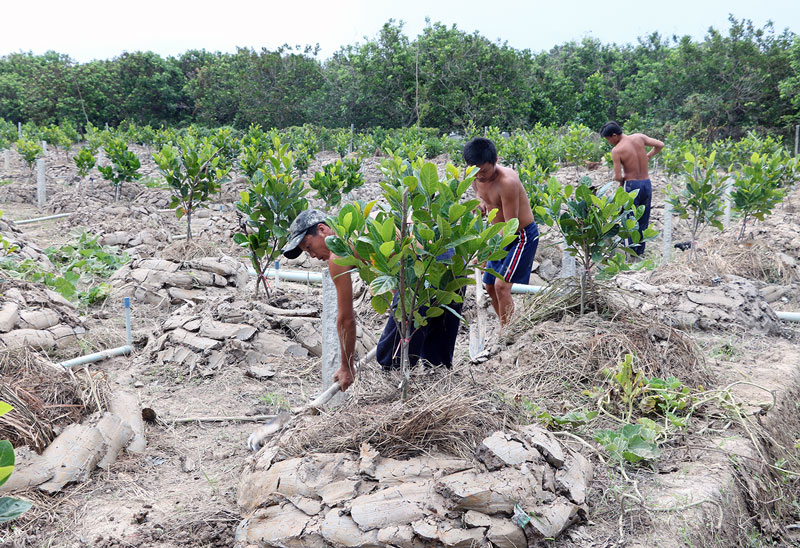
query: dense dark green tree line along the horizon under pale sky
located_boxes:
[0,17,800,139]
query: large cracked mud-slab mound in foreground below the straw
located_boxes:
[241,425,592,548]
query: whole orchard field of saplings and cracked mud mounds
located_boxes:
[0,116,800,548]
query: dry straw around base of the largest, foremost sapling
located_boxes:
[281,369,506,459]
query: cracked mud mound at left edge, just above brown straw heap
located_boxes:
[0,277,86,350]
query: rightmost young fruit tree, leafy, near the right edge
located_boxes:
[731,152,785,240]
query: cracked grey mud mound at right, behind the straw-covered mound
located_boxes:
[616,273,782,335]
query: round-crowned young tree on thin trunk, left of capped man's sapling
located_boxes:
[153,135,231,240]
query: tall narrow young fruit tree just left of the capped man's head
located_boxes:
[233,137,308,298]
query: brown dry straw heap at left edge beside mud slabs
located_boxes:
[0,351,108,453]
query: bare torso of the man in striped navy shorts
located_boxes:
[472,164,533,230]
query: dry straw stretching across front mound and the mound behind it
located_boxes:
[274,280,713,459]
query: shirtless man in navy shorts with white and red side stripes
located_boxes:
[464,137,539,327]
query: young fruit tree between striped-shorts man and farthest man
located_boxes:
[535,178,658,314]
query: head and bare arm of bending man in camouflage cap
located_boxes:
[282,209,356,392]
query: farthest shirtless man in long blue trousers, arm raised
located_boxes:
[600,122,664,256]
